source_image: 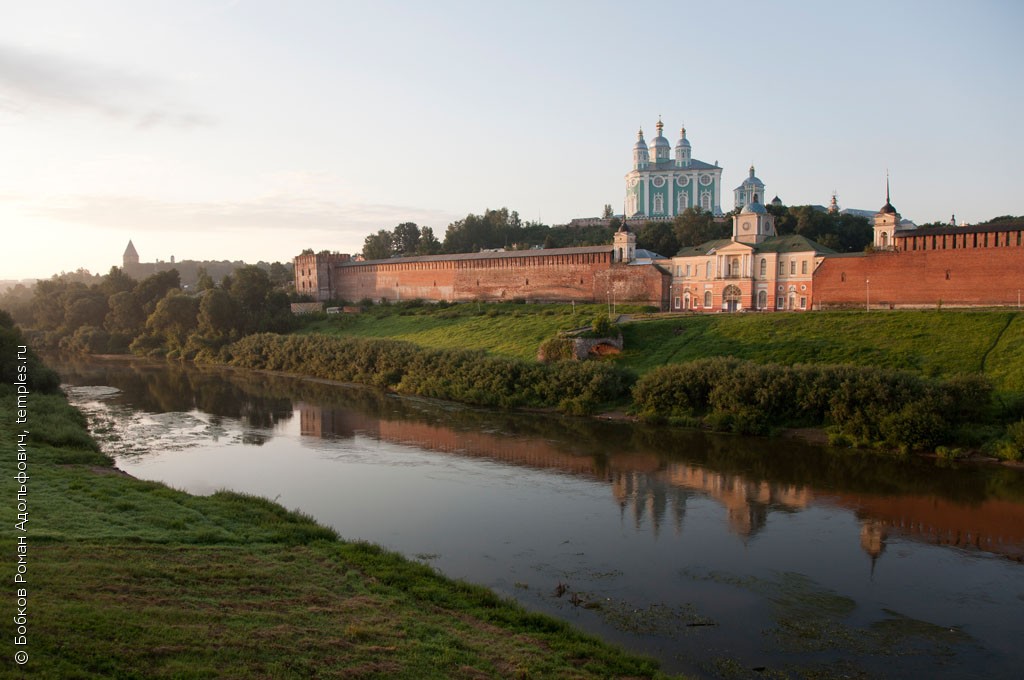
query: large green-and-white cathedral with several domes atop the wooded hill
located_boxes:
[626,119,722,220]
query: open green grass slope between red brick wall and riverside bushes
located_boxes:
[306,305,1024,392]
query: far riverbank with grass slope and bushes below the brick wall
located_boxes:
[288,301,1024,460]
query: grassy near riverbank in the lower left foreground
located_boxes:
[0,394,665,678]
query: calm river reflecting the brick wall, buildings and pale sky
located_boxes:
[53,359,1024,678]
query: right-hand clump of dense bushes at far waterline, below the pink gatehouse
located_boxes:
[633,357,991,451]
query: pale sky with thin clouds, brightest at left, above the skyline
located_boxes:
[0,0,1024,280]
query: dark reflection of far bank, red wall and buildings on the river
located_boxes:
[60,358,1024,560]
